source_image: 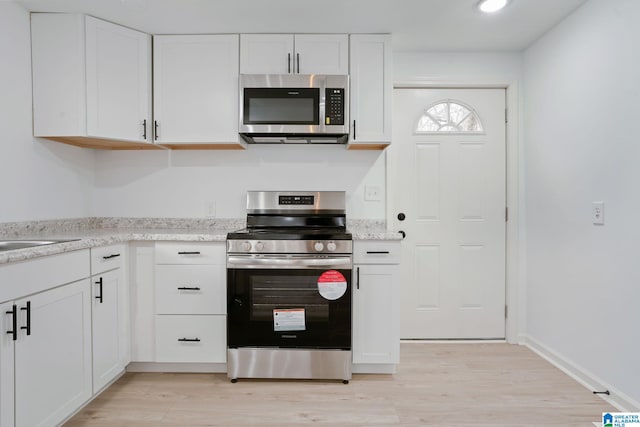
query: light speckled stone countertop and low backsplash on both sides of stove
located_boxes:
[0,218,402,265]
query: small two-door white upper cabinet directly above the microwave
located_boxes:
[240,34,349,74]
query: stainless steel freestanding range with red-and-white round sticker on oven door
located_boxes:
[227,191,353,383]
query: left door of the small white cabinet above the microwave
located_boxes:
[240,34,294,74]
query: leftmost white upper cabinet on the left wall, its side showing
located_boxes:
[31,13,155,149]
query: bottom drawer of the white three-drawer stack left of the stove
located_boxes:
[156,315,227,363]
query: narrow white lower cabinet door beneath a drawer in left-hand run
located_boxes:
[91,269,125,393]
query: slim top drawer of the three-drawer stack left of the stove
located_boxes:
[156,242,226,265]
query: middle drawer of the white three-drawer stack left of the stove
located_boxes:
[156,265,226,314]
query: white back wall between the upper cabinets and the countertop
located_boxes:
[92,145,386,219]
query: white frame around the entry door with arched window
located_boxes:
[385,80,526,344]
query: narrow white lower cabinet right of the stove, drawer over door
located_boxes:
[353,241,400,373]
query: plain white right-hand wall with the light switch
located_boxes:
[524,0,640,410]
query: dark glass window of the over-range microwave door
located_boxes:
[243,88,320,125]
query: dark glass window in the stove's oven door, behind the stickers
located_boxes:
[251,275,329,321]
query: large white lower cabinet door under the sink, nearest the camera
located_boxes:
[15,279,91,427]
